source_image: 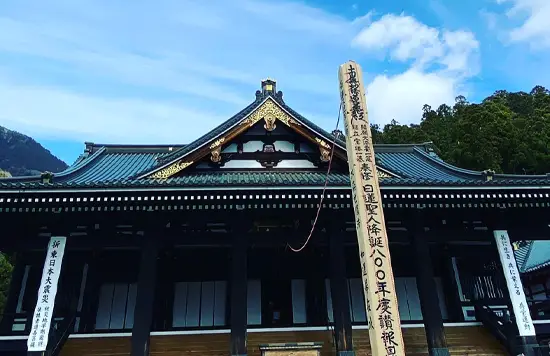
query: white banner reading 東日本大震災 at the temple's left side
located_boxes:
[27,236,67,351]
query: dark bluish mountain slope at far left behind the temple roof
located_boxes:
[0,126,67,176]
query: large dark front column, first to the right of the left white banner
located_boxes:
[131,230,161,356]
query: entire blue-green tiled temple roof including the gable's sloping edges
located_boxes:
[0,80,550,190]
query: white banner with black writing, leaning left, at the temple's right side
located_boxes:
[493,230,535,336]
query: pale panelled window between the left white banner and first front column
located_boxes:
[95,283,137,330]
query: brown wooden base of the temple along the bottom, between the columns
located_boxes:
[61,326,506,356]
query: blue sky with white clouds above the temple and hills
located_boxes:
[0,0,550,163]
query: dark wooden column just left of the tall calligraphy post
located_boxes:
[329,227,354,355]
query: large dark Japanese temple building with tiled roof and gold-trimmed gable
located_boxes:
[0,79,550,356]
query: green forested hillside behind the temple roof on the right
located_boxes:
[372,86,550,174]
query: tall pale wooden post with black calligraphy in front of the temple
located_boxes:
[338,61,405,356]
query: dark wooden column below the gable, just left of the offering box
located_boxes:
[230,221,248,356]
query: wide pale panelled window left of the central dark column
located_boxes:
[172,281,227,328]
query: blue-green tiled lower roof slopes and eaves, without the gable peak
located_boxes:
[0,145,550,189]
